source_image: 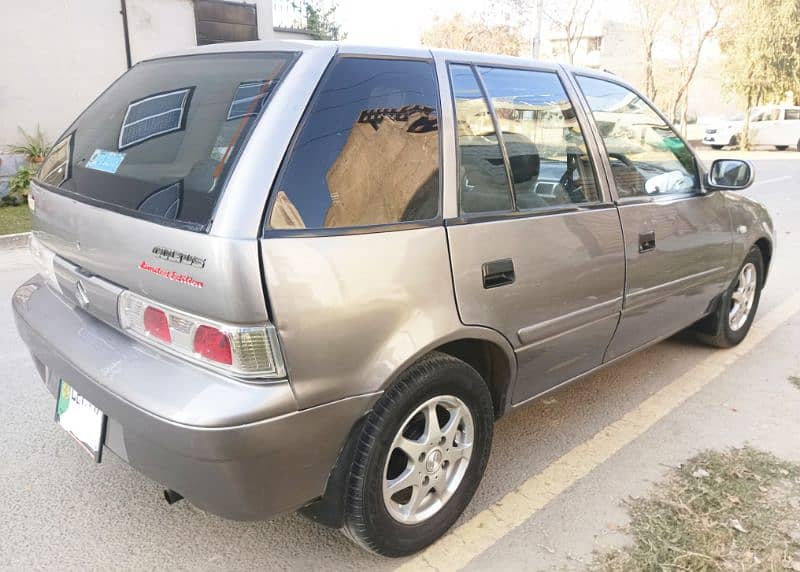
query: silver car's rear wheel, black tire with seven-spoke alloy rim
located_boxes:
[342,352,494,557]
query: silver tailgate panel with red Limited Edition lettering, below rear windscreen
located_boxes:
[31,183,268,326]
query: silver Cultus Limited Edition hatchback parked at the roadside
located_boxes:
[13,42,774,556]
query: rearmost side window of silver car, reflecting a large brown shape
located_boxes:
[269,58,439,229]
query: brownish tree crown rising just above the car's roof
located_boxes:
[420,14,525,56]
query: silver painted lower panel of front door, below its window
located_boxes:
[607,193,733,358]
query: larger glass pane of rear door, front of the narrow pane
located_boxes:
[478,67,600,210]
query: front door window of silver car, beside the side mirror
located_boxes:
[577,76,700,198]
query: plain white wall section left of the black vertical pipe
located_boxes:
[0,0,125,145]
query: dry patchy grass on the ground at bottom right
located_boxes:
[592,447,800,571]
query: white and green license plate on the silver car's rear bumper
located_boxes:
[56,379,106,463]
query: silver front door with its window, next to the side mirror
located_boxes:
[576,75,732,359]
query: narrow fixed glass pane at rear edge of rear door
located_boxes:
[450,65,512,213]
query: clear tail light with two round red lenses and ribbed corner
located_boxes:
[117,291,286,379]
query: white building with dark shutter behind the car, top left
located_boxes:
[0,0,309,147]
